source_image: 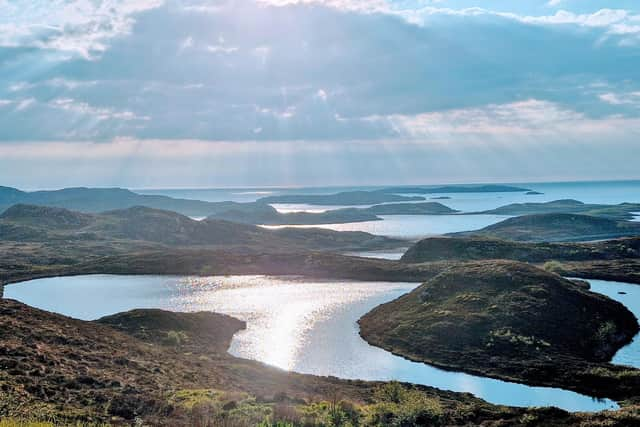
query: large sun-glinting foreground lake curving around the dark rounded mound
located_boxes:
[5,275,616,411]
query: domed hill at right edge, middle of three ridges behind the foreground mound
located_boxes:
[450,213,640,242]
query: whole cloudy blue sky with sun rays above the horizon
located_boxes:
[0,0,640,189]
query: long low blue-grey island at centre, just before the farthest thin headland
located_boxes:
[258,191,425,206]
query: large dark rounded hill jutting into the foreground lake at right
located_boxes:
[359,261,640,397]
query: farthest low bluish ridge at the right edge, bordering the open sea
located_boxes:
[474,199,640,220]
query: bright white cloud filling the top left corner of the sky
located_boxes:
[0,0,162,59]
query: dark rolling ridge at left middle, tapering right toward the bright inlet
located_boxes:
[0,205,404,251]
